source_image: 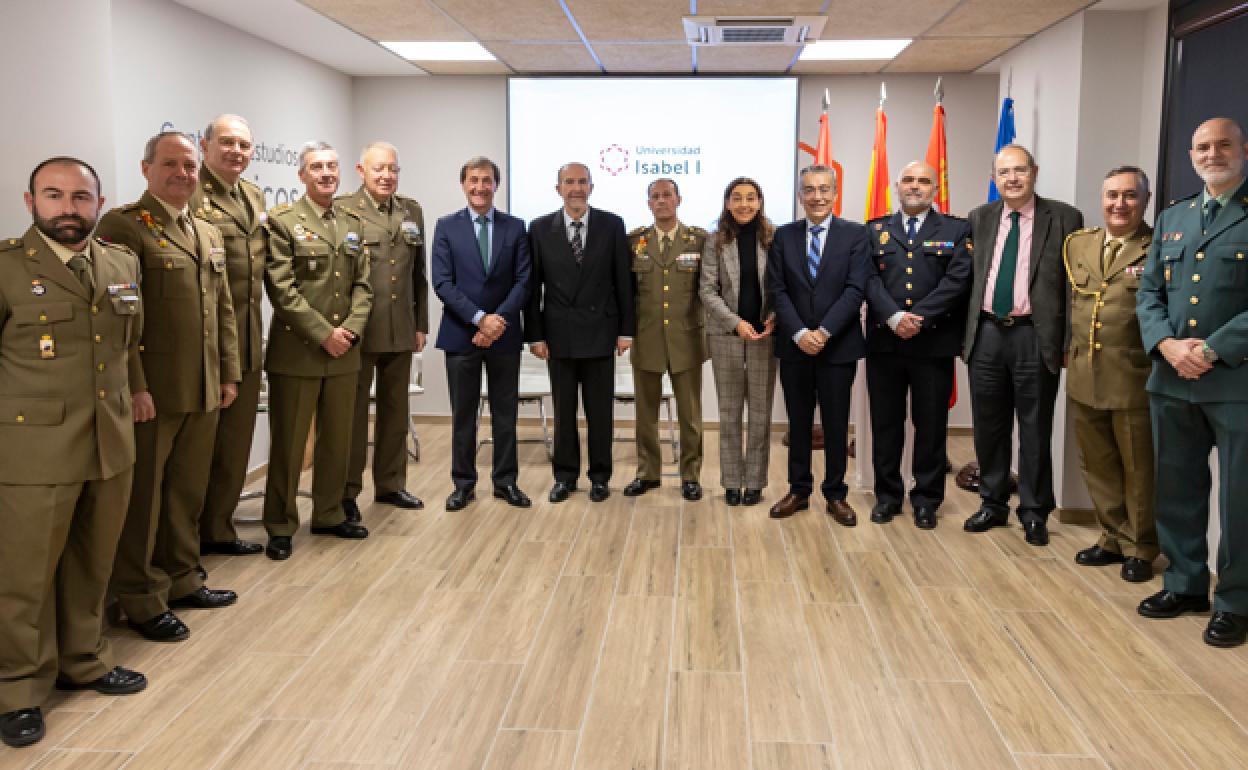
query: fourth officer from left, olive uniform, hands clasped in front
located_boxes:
[265,142,372,560]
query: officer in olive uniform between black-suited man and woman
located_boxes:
[624,178,706,500]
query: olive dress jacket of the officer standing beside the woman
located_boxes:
[628,225,708,372]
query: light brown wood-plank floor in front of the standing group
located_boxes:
[0,426,1248,770]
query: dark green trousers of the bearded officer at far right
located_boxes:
[1148,393,1248,615]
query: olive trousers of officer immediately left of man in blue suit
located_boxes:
[346,351,412,499]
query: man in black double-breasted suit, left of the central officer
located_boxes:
[524,163,636,503]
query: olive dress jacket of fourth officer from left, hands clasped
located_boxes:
[265,196,373,377]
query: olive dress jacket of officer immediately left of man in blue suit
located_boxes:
[334,186,429,353]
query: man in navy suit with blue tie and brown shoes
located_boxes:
[766,166,871,527]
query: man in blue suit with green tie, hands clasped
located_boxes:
[432,157,530,510]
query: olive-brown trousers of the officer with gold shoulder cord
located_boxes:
[1067,398,1158,562]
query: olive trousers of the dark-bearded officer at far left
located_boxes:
[0,470,131,713]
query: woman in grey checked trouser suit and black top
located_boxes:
[698,177,776,505]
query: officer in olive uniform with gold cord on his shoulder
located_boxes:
[1065,166,1157,583]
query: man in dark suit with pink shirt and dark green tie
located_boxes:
[962,145,1083,545]
